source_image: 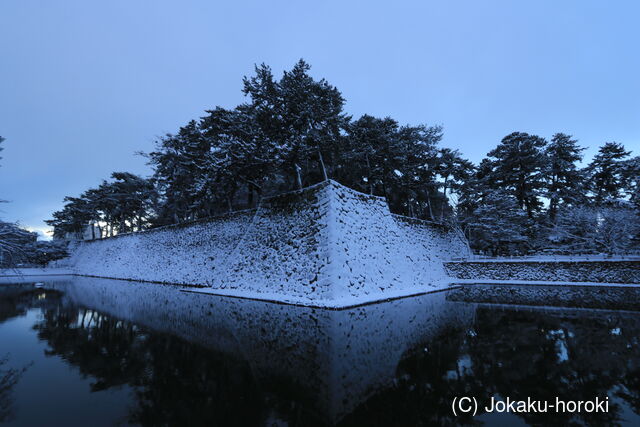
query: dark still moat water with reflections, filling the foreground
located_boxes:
[0,278,640,426]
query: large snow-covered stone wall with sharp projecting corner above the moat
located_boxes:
[69,181,468,306]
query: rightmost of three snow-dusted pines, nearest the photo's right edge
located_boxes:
[585,142,630,205]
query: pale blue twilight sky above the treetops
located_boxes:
[0,0,640,237]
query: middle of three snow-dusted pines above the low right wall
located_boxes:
[544,133,585,222]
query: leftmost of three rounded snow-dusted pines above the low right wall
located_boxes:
[488,132,546,218]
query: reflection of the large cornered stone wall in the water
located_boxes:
[47,277,475,423]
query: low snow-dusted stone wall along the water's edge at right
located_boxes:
[445,261,640,283]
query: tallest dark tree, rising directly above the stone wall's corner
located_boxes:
[244,59,349,188]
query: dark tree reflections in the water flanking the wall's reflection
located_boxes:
[11,293,640,425]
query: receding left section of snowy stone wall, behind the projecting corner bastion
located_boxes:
[65,211,255,285]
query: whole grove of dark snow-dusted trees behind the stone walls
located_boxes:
[41,60,640,255]
